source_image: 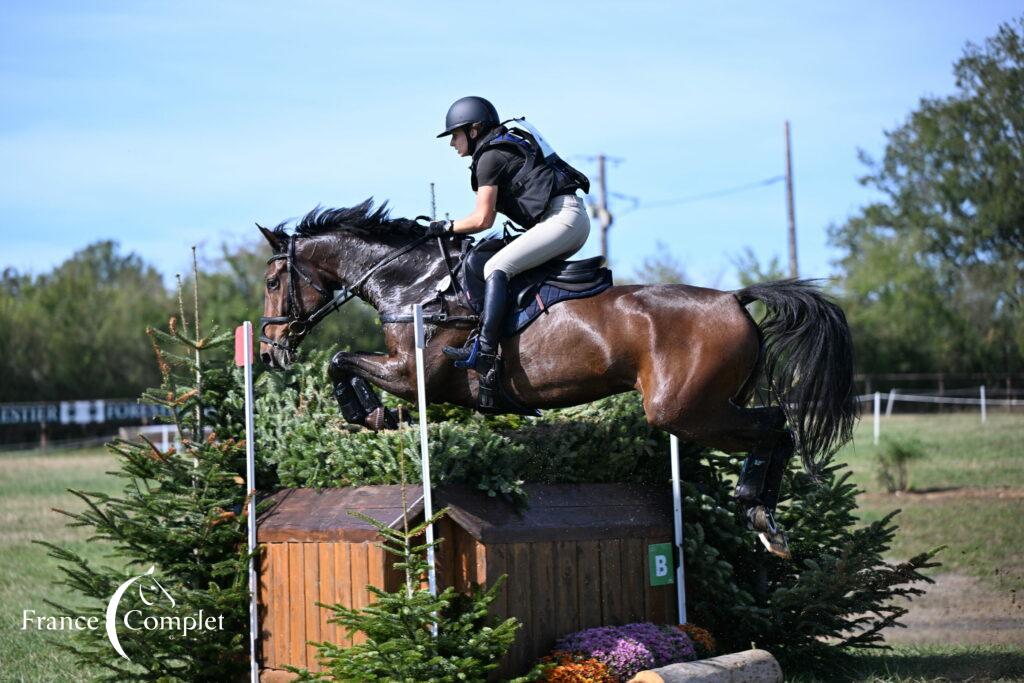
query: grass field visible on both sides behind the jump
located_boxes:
[0,414,1024,683]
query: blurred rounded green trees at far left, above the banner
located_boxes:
[0,241,172,401]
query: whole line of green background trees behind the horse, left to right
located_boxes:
[0,17,1024,401]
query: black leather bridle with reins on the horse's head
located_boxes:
[259,234,429,351]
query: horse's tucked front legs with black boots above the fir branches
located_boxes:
[328,351,410,431]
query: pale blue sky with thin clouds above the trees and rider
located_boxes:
[0,0,1022,288]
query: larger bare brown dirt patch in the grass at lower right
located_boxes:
[884,573,1024,645]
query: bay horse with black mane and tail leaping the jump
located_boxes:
[257,200,856,556]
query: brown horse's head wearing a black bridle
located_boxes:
[257,225,337,370]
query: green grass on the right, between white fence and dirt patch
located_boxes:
[838,413,1024,595]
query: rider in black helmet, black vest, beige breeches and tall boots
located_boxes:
[428,97,590,412]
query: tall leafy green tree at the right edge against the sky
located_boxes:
[830,17,1024,372]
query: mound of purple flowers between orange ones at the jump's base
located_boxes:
[555,624,695,680]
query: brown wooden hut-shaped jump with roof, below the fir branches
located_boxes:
[257,484,678,680]
